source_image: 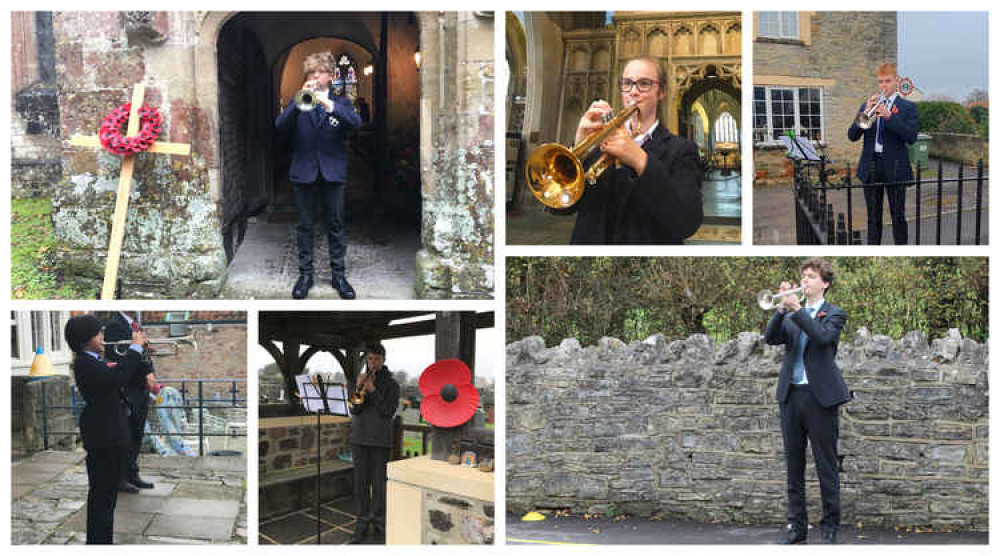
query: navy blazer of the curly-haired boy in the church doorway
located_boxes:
[274,95,361,183]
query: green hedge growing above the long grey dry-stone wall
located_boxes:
[506,257,989,345]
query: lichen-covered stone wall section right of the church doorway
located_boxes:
[416,12,494,299]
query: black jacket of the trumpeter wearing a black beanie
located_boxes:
[73,350,145,451]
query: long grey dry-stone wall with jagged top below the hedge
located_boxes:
[507,329,989,531]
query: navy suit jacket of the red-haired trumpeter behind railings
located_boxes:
[847,95,918,183]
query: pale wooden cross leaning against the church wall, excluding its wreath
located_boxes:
[69,85,191,299]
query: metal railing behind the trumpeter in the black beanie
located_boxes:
[41,378,247,456]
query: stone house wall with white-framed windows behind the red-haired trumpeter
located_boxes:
[753,12,897,184]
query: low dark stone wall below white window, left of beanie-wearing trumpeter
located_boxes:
[10,376,76,454]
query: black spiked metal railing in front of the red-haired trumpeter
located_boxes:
[793,159,989,245]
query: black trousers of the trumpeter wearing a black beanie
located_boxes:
[87,446,128,544]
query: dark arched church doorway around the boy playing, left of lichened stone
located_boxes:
[215,12,422,298]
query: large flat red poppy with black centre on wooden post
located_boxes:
[419,359,479,427]
